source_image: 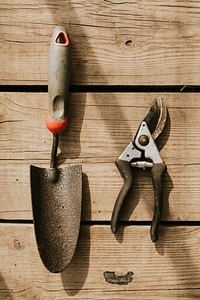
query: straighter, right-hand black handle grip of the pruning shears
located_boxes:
[151,162,167,242]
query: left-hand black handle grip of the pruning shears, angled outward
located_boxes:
[111,159,133,233]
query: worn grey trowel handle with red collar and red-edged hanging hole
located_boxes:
[46,26,70,133]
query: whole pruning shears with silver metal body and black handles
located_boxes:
[111,98,167,242]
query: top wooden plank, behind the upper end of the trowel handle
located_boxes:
[0,0,200,85]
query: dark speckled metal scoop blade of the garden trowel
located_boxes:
[30,165,82,273]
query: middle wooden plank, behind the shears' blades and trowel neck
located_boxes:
[0,93,200,221]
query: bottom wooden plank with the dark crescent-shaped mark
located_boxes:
[0,224,200,300]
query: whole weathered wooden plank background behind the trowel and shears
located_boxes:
[0,0,200,300]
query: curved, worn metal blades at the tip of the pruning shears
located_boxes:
[143,97,167,140]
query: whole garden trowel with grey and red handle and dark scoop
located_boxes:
[30,26,82,273]
